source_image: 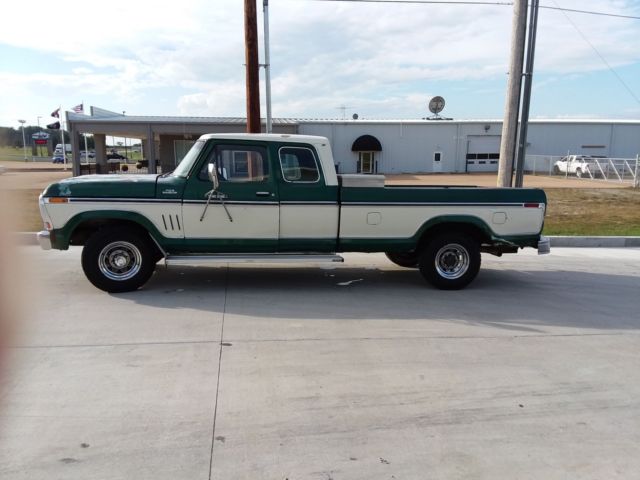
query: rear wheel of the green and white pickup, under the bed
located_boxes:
[419,233,481,290]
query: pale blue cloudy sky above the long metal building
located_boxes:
[0,0,640,127]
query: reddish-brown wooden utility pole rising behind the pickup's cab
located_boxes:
[244,0,261,133]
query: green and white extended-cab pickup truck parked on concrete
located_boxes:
[38,134,549,292]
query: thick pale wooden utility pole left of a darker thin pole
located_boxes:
[498,0,527,187]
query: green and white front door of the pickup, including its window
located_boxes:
[182,141,280,252]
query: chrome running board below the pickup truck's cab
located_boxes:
[165,253,344,266]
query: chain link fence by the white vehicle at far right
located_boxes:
[524,155,640,187]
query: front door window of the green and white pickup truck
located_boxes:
[200,145,269,183]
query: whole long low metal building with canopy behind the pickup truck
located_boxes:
[67,107,640,175]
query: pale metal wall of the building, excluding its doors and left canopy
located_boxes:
[298,120,640,174]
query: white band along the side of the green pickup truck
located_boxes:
[40,201,544,240]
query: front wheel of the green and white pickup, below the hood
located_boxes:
[82,228,156,293]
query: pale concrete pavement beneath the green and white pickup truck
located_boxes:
[0,247,640,480]
